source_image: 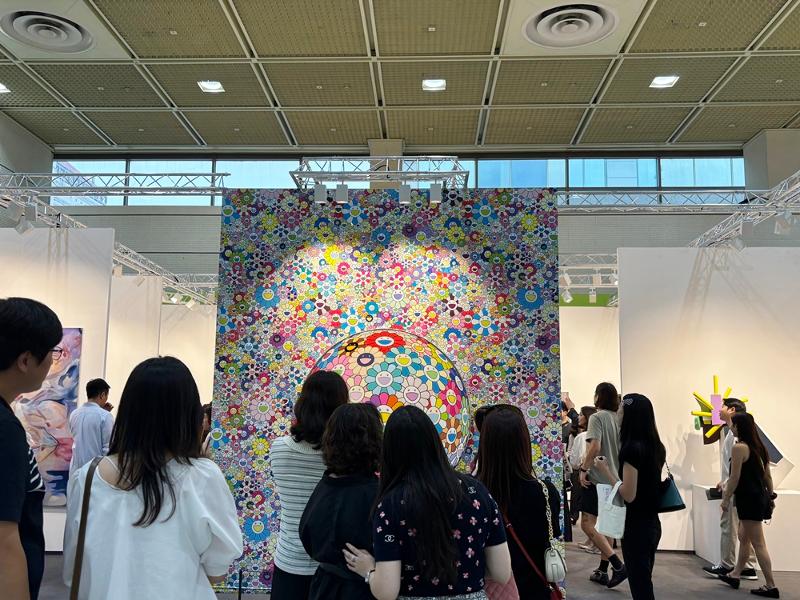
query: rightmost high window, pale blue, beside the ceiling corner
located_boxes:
[661,157,744,188]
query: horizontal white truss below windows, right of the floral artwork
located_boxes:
[556,189,767,214]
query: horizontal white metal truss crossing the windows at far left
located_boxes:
[0,173,228,196]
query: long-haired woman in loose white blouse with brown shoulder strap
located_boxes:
[64,357,242,600]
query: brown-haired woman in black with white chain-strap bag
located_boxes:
[478,404,561,600]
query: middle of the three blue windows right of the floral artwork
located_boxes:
[569,158,658,189]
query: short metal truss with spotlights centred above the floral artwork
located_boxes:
[291,156,469,191]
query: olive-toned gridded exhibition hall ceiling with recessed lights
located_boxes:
[0,0,800,154]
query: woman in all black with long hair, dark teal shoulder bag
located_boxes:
[595,394,667,600]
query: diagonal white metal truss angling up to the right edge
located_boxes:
[689,166,800,248]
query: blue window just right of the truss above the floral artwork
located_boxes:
[478,159,566,188]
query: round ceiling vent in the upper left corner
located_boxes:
[0,10,94,54]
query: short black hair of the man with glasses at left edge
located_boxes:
[0,298,64,371]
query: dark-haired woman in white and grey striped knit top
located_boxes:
[269,371,348,600]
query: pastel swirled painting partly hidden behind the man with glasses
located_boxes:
[14,328,83,506]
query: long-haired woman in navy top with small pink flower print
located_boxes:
[343,406,511,600]
